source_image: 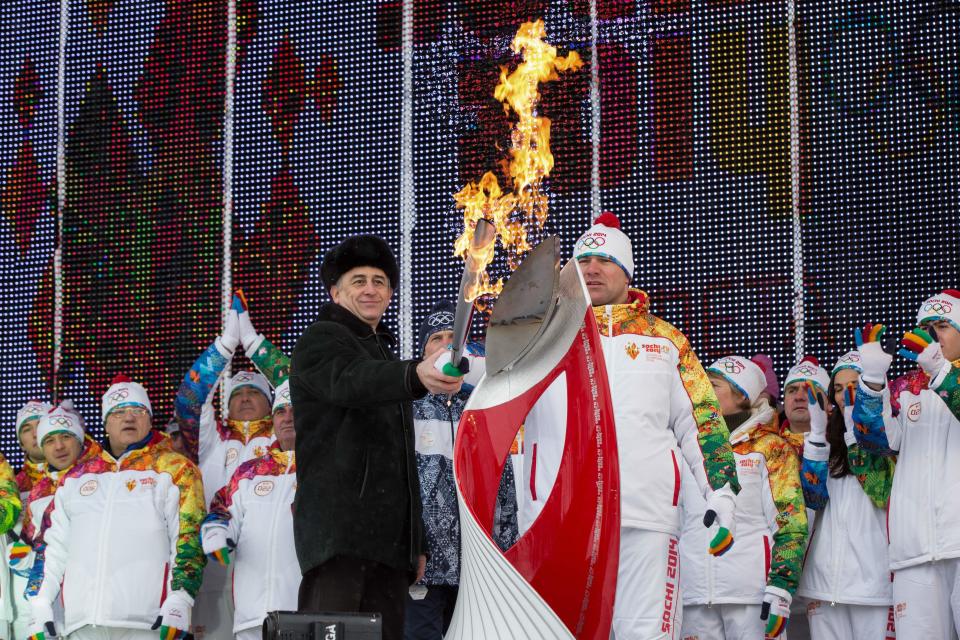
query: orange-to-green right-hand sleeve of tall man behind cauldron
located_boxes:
[674,338,740,493]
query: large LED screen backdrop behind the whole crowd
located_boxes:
[0,0,960,461]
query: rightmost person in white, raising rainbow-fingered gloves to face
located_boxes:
[853,289,960,640]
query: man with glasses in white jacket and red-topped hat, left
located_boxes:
[28,376,205,640]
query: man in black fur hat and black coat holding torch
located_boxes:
[290,235,462,640]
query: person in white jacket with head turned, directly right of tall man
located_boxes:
[680,355,807,640]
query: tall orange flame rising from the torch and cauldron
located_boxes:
[454,20,583,301]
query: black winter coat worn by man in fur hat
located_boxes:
[290,303,427,573]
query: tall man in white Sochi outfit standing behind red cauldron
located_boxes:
[520,213,740,640]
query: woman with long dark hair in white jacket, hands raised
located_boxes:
[797,351,895,640]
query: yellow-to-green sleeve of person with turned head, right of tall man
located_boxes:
[762,436,807,594]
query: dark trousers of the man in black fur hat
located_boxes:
[298,556,410,640]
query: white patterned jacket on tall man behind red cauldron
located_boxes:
[520,289,740,535]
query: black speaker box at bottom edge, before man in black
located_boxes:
[263,611,382,640]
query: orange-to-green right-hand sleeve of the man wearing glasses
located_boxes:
[164,452,207,597]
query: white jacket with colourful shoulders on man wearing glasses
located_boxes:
[28,432,206,634]
